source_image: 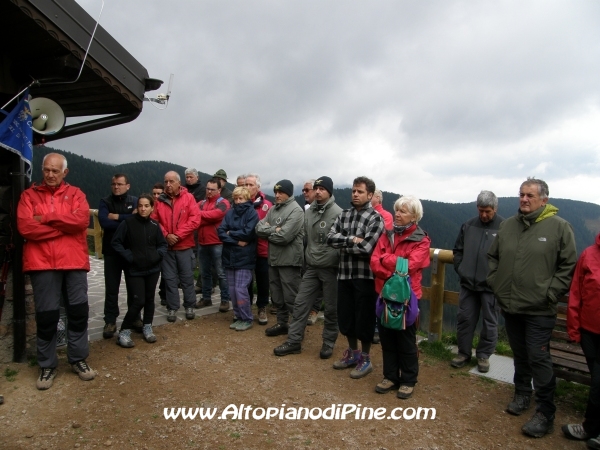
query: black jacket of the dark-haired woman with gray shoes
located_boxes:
[112,214,168,277]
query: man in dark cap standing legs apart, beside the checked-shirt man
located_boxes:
[273,177,342,359]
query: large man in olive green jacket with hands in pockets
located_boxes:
[487,178,577,437]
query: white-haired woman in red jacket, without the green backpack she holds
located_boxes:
[371,195,431,399]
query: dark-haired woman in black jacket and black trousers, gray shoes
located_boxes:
[112,194,167,348]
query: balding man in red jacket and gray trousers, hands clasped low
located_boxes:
[151,171,200,322]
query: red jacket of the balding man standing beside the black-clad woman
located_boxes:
[151,186,200,250]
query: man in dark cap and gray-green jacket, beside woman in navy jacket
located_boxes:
[256,180,304,336]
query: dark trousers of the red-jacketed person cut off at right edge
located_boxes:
[580,328,600,436]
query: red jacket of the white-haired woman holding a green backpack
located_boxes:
[371,225,431,300]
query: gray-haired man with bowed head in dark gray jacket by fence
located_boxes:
[451,191,504,372]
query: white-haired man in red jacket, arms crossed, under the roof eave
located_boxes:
[17,153,96,390]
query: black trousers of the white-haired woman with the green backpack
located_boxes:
[377,321,419,386]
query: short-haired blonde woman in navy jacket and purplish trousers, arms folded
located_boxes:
[218,186,258,331]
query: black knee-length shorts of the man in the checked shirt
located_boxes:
[337,278,377,342]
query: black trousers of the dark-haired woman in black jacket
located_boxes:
[121,272,160,330]
